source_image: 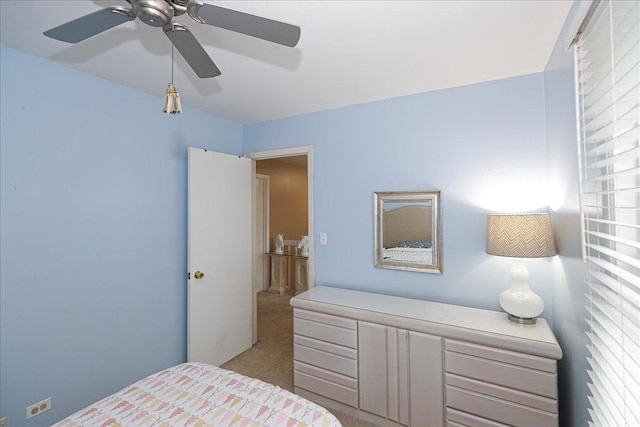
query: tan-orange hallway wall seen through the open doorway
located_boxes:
[256,159,309,250]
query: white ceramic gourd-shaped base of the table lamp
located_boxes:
[500,258,544,324]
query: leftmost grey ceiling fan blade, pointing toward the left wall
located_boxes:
[43,6,136,43]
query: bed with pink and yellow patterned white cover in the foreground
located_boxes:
[54,363,340,427]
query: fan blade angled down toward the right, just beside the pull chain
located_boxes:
[164,22,222,78]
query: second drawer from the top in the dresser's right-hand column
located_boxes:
[445,351,558,399]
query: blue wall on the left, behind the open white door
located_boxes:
[0,46,242,427]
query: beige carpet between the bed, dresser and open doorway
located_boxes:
[222,292,375,427]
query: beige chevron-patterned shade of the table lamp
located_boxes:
[486,213,556,258]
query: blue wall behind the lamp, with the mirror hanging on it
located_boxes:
[244,73,552,314]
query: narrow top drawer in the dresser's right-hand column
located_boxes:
[445,340,557,374]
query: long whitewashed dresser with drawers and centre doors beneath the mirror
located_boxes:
[291,286,562,427]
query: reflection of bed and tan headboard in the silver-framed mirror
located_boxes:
[382,205,433,264]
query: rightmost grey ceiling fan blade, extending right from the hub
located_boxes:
[187,0,300,47]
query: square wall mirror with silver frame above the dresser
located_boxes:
[374,191,442,274]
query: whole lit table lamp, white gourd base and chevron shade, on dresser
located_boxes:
[486,213,556,324]
